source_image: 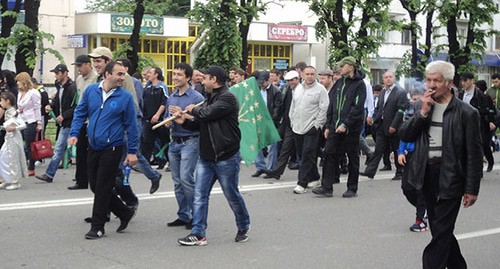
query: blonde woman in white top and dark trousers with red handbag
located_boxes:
[15,72,43,177]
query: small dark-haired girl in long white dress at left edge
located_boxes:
[0,92,28,190]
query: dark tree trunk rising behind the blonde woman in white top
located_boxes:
[16,0,41,76]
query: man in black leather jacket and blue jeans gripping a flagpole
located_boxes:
[174,66,250,246]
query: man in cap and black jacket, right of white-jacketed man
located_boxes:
[313,57,366,198]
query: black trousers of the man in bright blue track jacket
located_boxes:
[87,147,133,229]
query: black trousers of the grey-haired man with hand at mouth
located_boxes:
[422,160,467,269]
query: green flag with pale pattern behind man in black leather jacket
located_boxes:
[230,77,281,165]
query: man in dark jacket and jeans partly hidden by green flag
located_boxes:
[252,71,283,177]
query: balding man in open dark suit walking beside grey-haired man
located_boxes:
[360,71,408,180]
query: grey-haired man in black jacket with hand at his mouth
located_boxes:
[399,61,483,269]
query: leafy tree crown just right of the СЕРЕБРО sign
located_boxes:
[301,0,391,66]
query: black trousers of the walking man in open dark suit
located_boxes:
[365,130,403,177]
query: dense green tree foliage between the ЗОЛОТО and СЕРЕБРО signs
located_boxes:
[188,0,242,70]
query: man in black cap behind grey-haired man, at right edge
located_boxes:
[458,73,496,172]
